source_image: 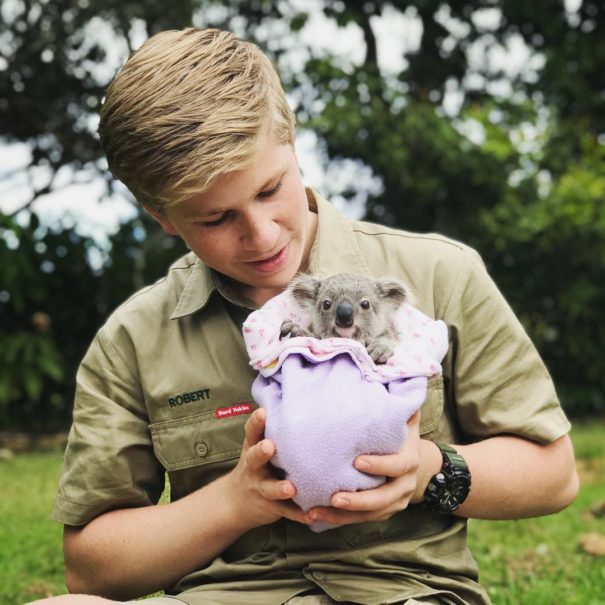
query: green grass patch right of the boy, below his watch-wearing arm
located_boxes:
[469,422,605,605]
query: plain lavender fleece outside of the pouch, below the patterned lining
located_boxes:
[252,354,427,531]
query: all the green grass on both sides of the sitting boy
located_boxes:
[0,421,605,605]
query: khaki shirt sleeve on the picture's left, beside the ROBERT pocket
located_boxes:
[52,326,164,525]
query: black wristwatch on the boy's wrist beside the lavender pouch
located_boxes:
[422,443,471,513]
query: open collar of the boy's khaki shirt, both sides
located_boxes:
[170,188,372,319]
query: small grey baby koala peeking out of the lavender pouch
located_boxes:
[280,273,409,364]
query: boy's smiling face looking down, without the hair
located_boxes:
[150,138,317,304]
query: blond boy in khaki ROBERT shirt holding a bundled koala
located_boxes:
[30,29,578,605]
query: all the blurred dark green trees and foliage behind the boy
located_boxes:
[0,0,605,429]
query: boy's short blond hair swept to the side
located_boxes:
[99,28,295,210]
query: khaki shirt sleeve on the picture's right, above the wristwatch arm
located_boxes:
[444,249,570,443]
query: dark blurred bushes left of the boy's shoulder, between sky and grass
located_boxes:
[0,213,184,432]
